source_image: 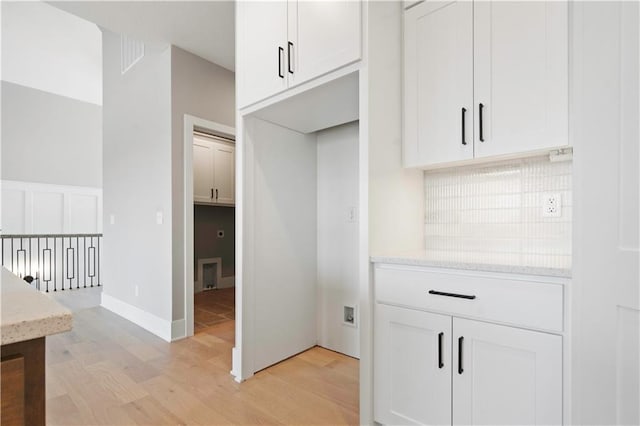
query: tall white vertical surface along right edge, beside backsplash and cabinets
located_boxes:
[570,2,640,424]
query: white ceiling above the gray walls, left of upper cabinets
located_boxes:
[49,0,235,71]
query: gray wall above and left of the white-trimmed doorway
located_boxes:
[171,46,235,320]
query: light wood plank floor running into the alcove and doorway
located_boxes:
[46,288,359,425]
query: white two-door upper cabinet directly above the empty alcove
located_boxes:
[236,0,362,108]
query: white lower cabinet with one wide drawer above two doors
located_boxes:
[373,267,563,425]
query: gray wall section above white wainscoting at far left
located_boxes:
[2,81,102,187]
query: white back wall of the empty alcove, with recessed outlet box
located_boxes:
[316,122,360,358]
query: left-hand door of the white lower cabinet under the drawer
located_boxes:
[373,304,451,425]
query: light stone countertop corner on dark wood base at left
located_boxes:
[0,267,73,345]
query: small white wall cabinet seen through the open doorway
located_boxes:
[193,137,235,205]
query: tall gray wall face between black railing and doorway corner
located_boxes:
[103,31,172,321]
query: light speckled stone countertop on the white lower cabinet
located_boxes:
[370,250,571,278]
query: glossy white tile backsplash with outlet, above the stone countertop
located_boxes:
[424,157,572,268]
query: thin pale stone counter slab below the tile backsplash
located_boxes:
[370,255,571,278]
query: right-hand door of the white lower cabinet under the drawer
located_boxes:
[453,318,562,425]
